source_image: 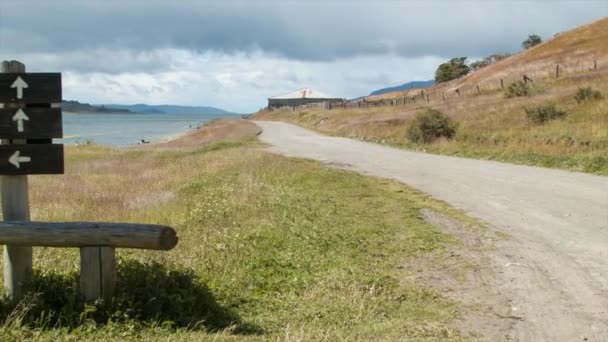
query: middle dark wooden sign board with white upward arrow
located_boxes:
[0,108,63,139]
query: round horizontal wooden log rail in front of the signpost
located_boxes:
[0,222,178,251]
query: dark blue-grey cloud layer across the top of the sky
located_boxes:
[0,0,608,66]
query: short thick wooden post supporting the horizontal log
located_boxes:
[80,247,116,304]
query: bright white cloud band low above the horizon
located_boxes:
[58,49,443,112]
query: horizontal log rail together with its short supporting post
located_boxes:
[0,221,178,303]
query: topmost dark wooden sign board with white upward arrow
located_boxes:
[0,73,61,104]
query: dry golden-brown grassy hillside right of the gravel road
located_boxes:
[256,19,608,175]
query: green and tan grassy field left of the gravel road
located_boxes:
[0,121,478,341]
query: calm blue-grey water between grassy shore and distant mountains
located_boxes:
[60,113,239,147]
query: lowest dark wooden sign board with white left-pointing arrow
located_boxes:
[0,144,63,175]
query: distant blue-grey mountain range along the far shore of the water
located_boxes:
[61,100,233,115]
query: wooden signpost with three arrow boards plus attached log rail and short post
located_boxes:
[0,61,177,302]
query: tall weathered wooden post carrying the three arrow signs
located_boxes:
[0,61,32,300]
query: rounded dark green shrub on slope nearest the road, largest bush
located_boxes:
[407,109,456,143]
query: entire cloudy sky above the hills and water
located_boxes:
[0,0,608,113]
